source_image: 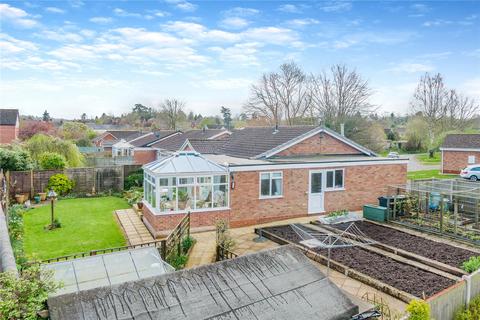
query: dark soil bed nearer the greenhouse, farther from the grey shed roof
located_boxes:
[324,221,480,268]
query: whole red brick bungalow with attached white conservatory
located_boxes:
[143,126,407,236]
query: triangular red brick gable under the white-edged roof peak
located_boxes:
[275,133,361,156]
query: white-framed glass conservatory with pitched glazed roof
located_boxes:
[143,151,229,214]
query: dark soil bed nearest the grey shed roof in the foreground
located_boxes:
[262,225,455,298]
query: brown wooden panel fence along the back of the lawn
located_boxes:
[8,165,141,197]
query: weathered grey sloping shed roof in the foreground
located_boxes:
[48,246,358,320]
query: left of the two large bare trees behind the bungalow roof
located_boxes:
[244,62,311,125]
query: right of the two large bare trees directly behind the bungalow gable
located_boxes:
[311,64,373,130]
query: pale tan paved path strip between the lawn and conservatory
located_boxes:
[115,209,155,245]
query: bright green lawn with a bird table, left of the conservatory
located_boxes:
[24,197,129,260]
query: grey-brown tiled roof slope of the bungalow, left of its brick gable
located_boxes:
[218,126,317,158]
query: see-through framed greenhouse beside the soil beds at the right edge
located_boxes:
[383,179,480,243]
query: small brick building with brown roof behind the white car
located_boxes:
[440,133,480,173]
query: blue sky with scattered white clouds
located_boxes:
[0,0,480,118]
